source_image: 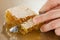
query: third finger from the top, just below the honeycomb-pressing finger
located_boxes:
[40,19,60,32]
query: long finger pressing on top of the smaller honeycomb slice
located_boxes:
[33,9,60,24]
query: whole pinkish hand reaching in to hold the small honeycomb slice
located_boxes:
[33,0,60,36]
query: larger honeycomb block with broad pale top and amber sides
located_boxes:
[5,6,36,25]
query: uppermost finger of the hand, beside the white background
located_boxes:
[39,0,59,13]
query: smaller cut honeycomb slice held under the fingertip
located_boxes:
[20,18,40,34]
